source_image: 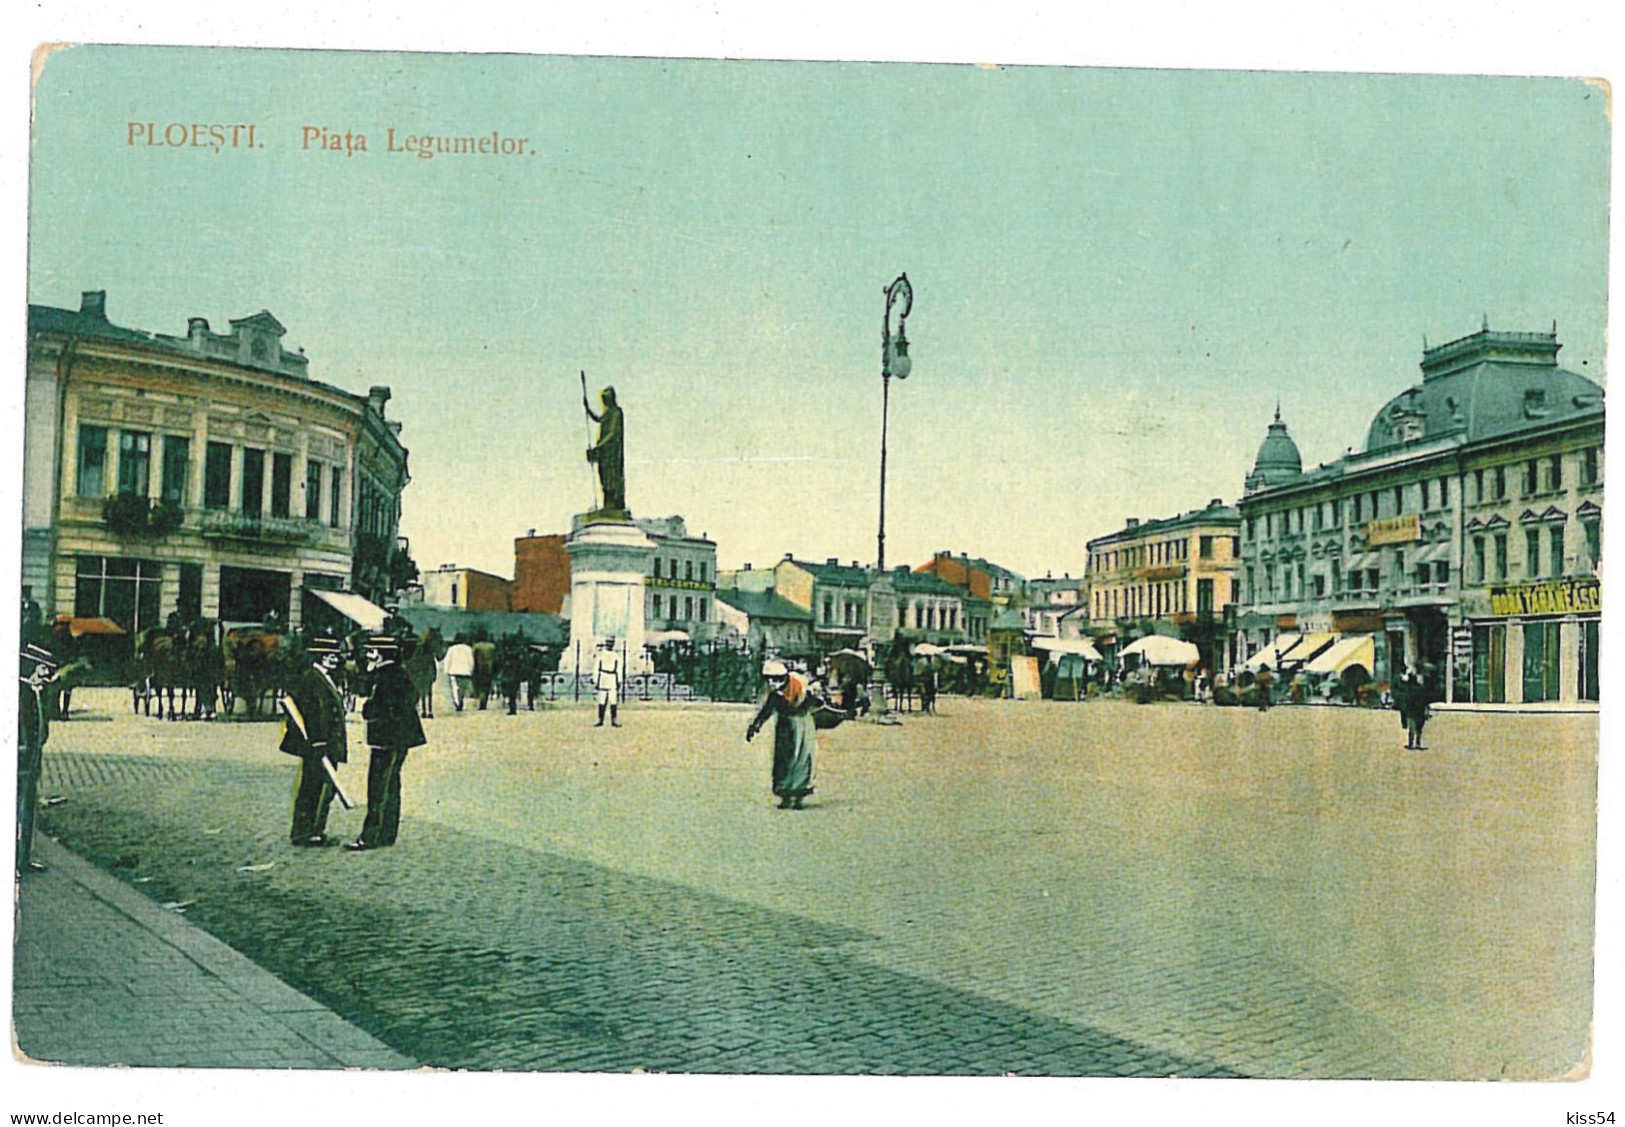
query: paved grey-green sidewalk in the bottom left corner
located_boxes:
[13,835,414,1069]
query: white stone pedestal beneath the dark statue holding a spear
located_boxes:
[559,513,655,676]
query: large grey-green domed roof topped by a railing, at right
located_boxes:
[1365,328,1602,453]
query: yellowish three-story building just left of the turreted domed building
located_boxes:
[1084,497,1242,669]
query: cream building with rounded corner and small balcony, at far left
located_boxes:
[23,291,410,633]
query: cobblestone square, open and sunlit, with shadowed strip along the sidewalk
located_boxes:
[16,692,1597,1078]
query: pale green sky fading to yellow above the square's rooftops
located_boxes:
[29,47,1609,575]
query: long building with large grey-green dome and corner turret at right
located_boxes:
[1232,326,1604,703]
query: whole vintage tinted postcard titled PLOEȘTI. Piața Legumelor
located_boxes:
[10,26,1625,1122]
